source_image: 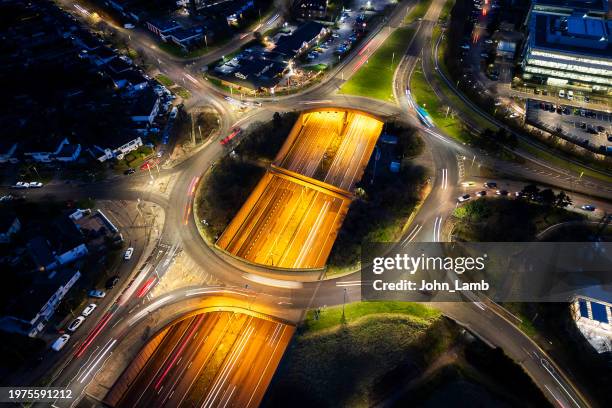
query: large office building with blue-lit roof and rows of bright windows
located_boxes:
[522,0,612,92]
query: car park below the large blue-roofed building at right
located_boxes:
[526,99,612,154]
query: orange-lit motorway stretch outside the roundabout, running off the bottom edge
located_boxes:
[105,311,295,408]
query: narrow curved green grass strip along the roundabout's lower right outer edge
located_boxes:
[304,302,440,333]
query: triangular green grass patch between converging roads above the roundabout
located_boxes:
[340,27,414,101]
